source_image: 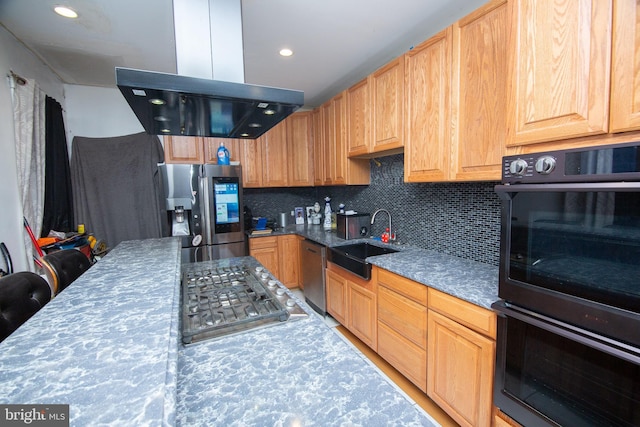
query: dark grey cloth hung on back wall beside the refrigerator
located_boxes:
[71,133,164,248]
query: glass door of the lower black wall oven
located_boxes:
[495,308,640,426]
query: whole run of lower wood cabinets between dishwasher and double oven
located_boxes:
[326,263,497,427]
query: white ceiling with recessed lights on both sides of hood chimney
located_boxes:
[0,0,487,108]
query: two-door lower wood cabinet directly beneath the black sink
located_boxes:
[325,263,378,351]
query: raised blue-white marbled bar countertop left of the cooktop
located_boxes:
[0,238,180,426]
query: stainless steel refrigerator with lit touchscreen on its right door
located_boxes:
[160,164,247,263]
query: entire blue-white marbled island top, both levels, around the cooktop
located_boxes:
[0,238,435,426]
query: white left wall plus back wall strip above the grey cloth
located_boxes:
[0,27,144,271]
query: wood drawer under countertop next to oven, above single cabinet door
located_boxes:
[429,288,497,339]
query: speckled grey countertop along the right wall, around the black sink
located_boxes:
[248,225,499,309]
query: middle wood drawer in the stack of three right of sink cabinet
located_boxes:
[378,285,427,349]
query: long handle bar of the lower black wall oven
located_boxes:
[491,300,640,365]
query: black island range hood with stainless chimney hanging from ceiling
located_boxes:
[116,0,304,139]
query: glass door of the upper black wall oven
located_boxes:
[502,183,640,313]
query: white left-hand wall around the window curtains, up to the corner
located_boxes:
[0,26,65,271]
